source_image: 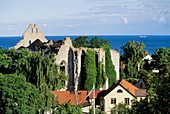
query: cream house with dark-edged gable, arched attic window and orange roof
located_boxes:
[98,79,146,113]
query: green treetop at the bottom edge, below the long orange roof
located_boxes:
[53,102,83,114]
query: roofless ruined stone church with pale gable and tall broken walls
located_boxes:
[14,24,120,90]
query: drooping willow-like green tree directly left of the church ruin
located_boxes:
[17,52,67,109]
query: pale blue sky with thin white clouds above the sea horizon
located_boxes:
[0,0,170,36]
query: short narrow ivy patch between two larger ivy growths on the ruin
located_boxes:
[96,62,107,89]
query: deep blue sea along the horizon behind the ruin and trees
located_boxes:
[0,35,170,54]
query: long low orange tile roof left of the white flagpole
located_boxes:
[52,90,88,105]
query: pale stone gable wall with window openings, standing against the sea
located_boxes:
[14,24,48,49]
